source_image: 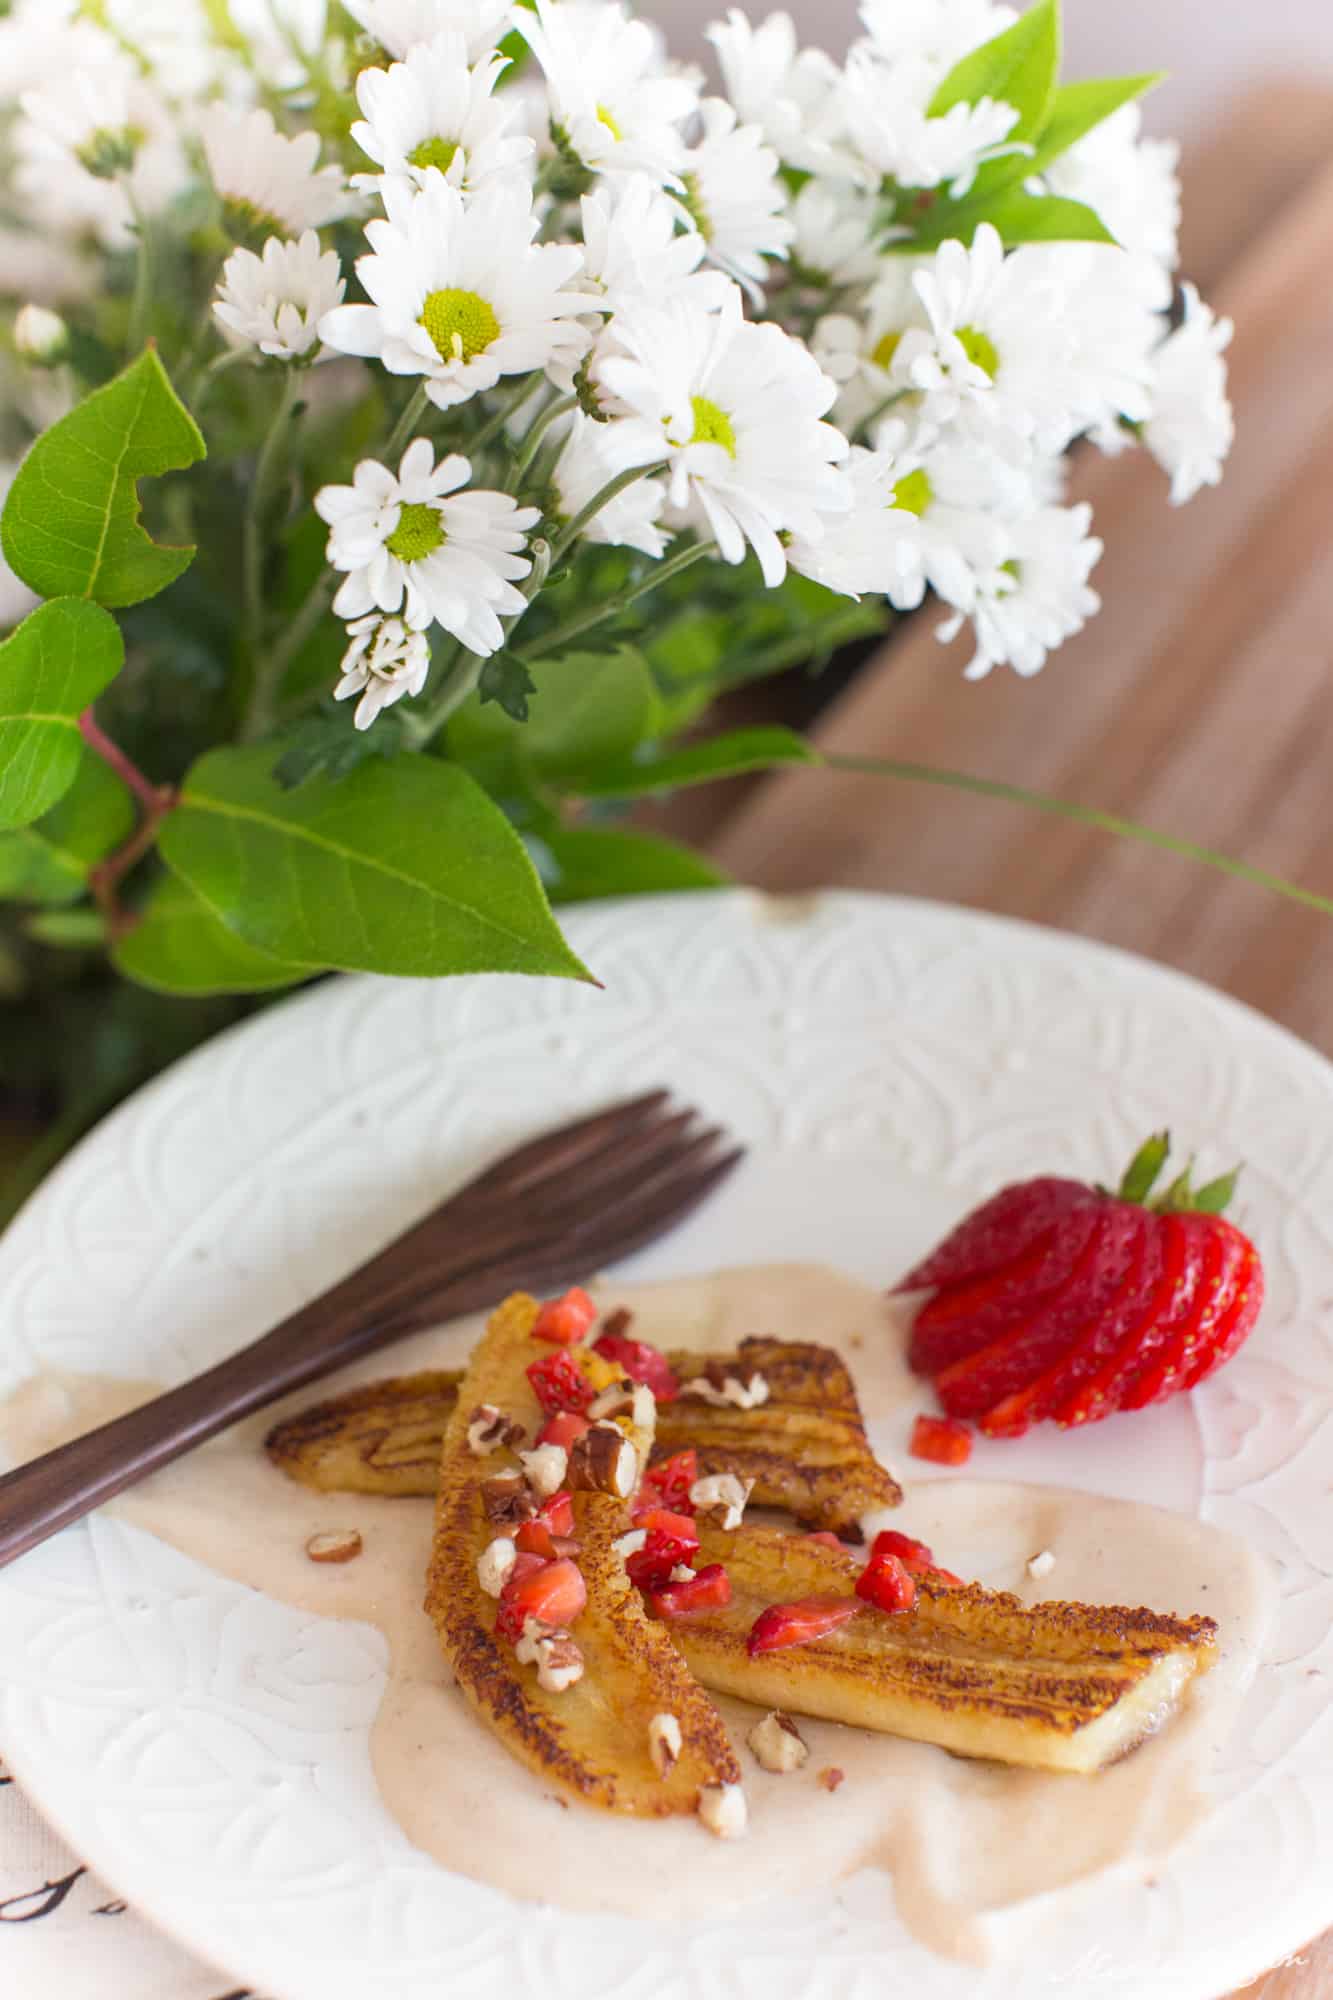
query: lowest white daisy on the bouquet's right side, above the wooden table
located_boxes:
[939,506,1103,680]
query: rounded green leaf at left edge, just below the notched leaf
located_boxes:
[0,598,124,828]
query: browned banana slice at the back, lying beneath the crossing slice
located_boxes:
[266,1340,903,1540]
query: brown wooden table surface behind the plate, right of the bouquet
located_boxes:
[658,84,1333,2000]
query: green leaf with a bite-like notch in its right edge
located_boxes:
[0,348,204,608]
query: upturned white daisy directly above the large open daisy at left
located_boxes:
[352,28,534,194]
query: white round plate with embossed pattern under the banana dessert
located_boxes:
[0,892,1333,2000]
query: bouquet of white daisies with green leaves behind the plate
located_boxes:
[0,0,1231,1168]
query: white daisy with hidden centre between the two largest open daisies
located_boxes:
[580,174,731,312]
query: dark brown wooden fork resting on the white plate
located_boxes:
[0,1090,743,1566]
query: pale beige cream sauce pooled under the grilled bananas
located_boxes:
[0,1266,1275,1958]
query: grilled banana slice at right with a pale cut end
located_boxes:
[671,1524,1217,1774]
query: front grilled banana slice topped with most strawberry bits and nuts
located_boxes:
[426,1294,743,1832]
